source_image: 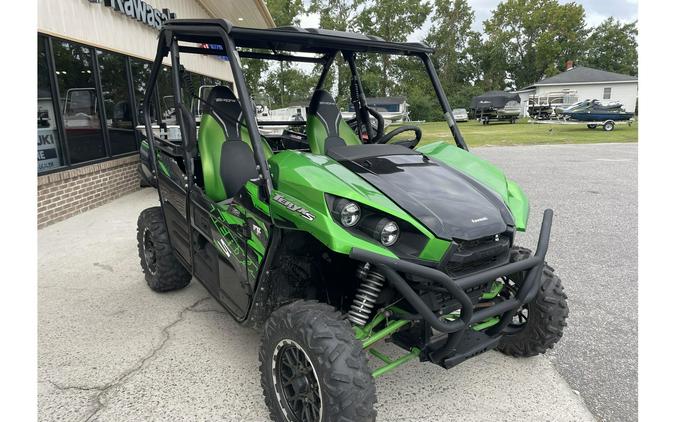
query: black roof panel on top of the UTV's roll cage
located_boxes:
[163,19,433,54]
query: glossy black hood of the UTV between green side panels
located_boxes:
[328,145,513,240]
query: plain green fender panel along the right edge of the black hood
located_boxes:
[416,141,530,231]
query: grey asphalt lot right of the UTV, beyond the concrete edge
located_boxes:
[474,144,638,421]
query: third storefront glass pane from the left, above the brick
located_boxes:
[96,50,136,155]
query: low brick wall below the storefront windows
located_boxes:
[37,155,140,228]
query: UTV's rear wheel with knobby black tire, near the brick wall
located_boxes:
[136,207,192,292]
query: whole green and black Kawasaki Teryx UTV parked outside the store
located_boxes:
[138,20,568,421]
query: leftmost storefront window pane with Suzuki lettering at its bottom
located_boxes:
[37,36,63,172]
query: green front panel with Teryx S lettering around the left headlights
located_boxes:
[269,151,449,260]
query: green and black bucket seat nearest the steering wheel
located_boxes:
[307,89,361,155]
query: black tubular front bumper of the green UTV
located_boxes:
[350,209,553,367]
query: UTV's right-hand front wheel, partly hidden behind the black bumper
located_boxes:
[497,247,569,357]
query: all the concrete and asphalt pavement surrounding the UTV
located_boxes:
[38,144,637,421]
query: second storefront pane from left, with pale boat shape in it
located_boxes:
[53,40,105,164]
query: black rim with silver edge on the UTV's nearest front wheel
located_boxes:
[272,340,322,422]
